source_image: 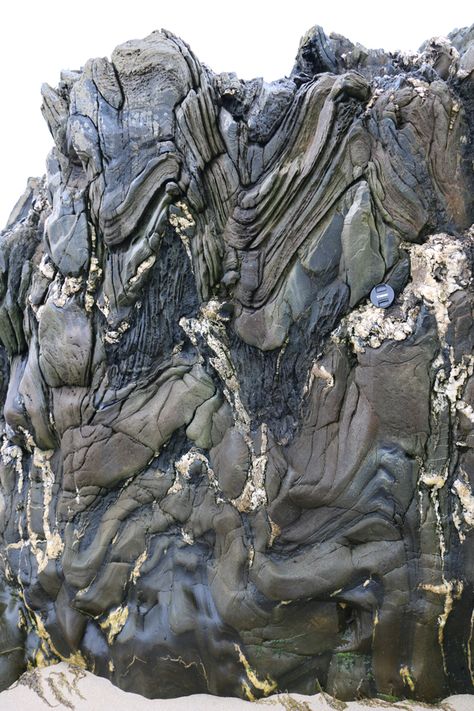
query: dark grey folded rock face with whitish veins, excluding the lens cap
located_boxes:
[0,27,474,700]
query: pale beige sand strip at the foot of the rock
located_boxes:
[0,663,474,711]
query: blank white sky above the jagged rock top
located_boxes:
[0,0,474,226]
